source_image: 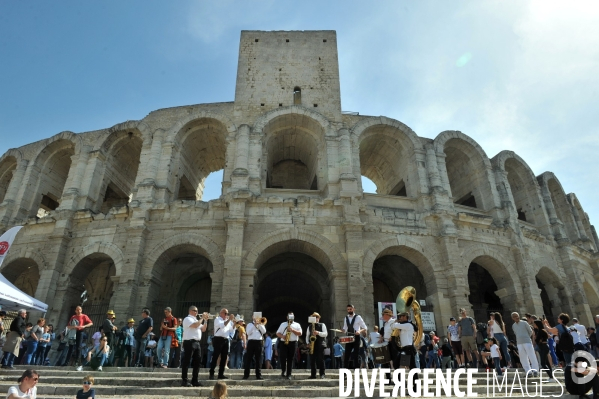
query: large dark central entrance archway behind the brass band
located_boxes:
[255,252,332,338]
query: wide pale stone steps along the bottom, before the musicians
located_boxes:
[0,366,577,399]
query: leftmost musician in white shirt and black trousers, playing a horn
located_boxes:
[181,306,207,387]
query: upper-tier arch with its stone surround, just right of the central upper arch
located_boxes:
[352,117,424,197]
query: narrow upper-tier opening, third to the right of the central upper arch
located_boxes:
[505,158,543,224]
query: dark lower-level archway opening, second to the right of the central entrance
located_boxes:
[468,263,510,323]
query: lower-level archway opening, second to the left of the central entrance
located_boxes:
[61,252,116,331]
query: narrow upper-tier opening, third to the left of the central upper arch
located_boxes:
[29,139,75,218]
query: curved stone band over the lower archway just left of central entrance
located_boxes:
[141,233,225,279]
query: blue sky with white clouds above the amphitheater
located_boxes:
[0,0,599,228]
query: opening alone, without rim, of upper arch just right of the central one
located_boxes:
[360,125,416,197]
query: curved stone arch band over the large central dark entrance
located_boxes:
[243,228,346,275]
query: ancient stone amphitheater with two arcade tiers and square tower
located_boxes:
[0,31,599,335]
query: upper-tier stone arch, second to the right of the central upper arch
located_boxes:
[433,131,496,210]
